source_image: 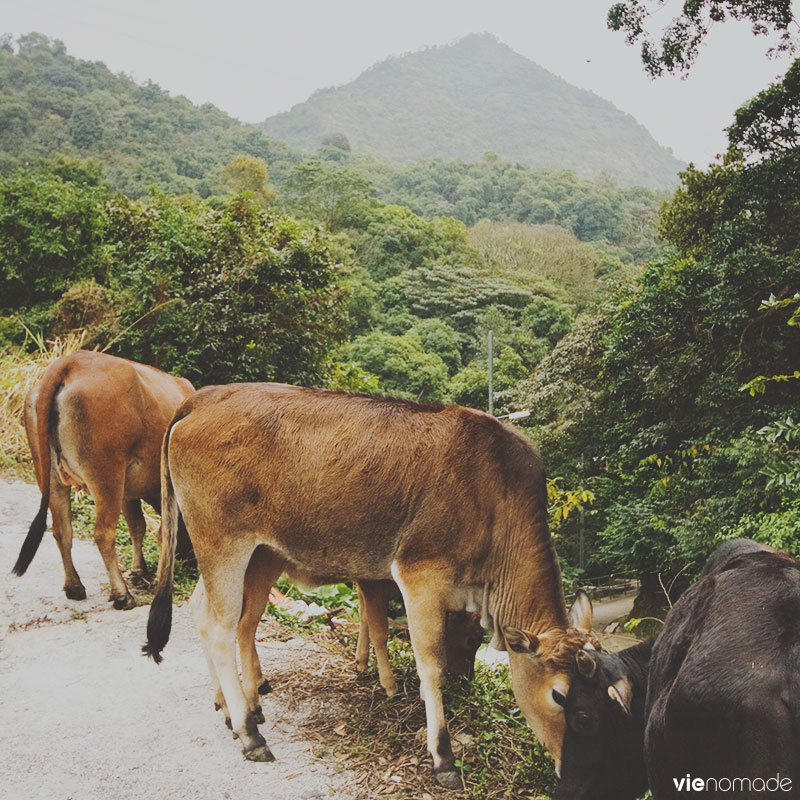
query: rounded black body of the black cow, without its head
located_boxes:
[645,552,800,798]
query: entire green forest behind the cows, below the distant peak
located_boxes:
[0,28,800,612]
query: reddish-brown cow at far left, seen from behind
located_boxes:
[13,350,194,608]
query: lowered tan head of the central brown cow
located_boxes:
[503,592,600,772]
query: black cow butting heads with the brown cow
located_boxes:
[556,539,800,800]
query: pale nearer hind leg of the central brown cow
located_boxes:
[192,551,274,761]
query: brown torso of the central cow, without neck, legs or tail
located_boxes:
[169,384,543,582]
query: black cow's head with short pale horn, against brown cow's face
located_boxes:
[556,650,647,800]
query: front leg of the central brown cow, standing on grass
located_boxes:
[393,565,461,789]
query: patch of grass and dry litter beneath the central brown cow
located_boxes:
[259,606,556,800]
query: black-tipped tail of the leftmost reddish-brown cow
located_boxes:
[11,363,69,576]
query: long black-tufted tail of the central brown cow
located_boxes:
[142,413,183,664]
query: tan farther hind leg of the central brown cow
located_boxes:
[237,545,284,723]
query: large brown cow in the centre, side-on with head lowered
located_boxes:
[145,384,590,786]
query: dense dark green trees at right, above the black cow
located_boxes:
[514,61,800,613]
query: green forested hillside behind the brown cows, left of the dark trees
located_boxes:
[0,34,665,407]
